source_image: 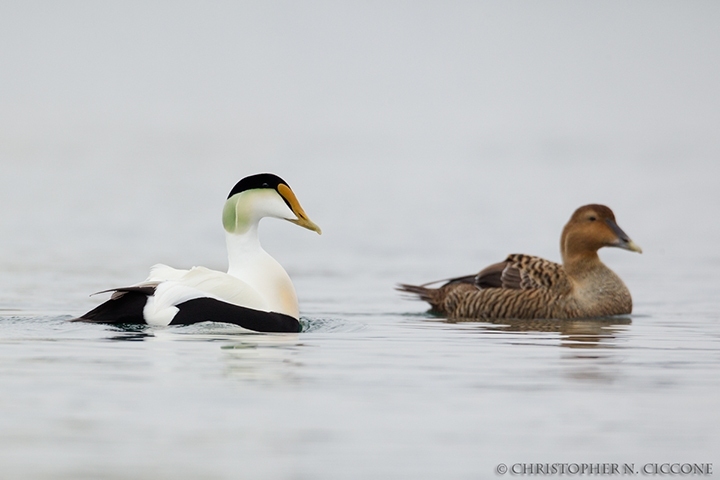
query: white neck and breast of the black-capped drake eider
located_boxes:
[225,223,299,318]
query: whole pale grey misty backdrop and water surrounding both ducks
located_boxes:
[0,1,720,478]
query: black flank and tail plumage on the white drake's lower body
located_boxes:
[75,286,302,333]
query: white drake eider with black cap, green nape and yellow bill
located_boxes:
[76,173,321,332]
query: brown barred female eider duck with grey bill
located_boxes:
[398,205,642,319]
